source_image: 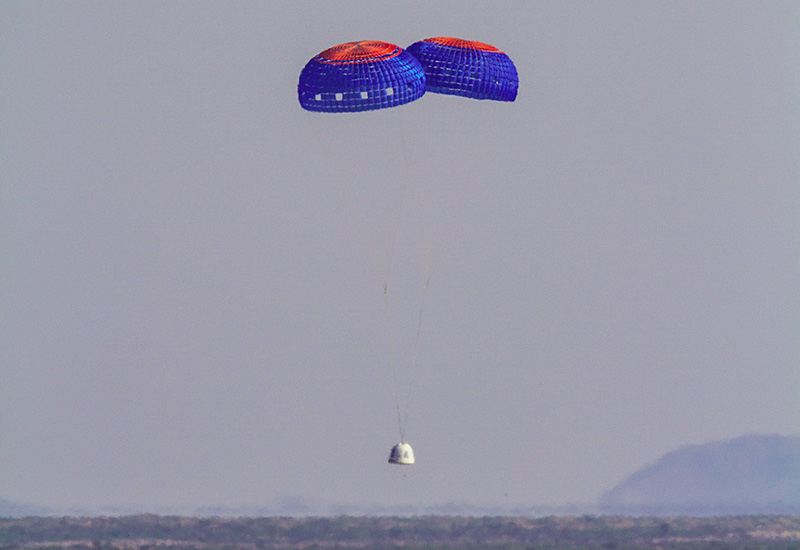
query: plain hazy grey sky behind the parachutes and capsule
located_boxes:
[0,0,800,508]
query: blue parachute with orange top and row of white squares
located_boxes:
[297,41,425,113]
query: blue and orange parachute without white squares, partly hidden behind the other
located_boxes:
[408,36,519,101]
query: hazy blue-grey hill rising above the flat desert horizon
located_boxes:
[599,435,800,515]
